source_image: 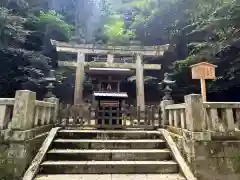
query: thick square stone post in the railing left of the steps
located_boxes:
[12,90,36,130]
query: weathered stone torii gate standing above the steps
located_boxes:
[51,40,169,110]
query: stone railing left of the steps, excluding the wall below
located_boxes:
[0,90,58,130]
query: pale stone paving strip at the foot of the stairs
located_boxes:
[35,174,186,180]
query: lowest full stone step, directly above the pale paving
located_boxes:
[40,161,178,174]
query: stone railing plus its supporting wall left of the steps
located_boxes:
[0,90,59,179]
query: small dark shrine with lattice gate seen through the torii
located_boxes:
[86,65,133,128]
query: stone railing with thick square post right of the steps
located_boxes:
[161,94,240,139]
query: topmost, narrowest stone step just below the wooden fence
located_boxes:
[57,130,162,139]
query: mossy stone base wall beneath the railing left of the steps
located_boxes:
[0,125,53,180]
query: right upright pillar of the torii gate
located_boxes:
[136,54,145,110]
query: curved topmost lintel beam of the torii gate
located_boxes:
[51,40,170,56]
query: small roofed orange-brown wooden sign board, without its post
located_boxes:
[191,62,216,79]
